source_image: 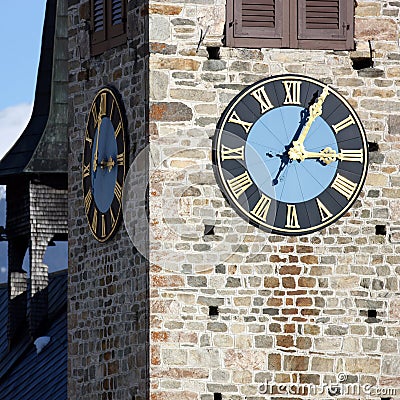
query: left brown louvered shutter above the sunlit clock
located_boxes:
[226,0,289,47]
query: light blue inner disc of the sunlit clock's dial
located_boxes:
[245,106,338,203]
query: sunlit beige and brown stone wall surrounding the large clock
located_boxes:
[149,0,400,400]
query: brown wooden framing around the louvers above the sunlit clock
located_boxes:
[225,0,355,50]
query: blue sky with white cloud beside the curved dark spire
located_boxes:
[0,0,46,158]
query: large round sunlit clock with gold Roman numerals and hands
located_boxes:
[213,75,368,235]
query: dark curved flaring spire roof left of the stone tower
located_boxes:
[0,0,68,184]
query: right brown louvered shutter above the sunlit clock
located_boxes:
[293,0,354,50]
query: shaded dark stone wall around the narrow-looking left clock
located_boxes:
[68,0,149,400]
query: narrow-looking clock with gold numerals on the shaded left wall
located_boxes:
[82,87,127,242]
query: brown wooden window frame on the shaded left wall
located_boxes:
[90,0,126,56]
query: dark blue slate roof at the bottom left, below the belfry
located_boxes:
[0,270,67,400]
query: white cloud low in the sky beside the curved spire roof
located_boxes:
[0,103,32,159]
